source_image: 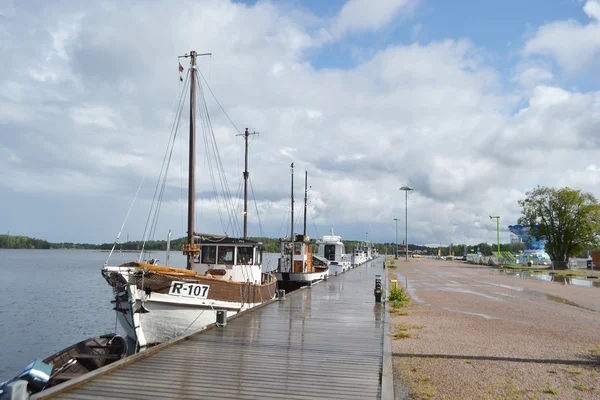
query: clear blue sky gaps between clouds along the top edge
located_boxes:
[300,0,589,67]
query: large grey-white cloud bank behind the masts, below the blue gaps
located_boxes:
[0,0,600,250]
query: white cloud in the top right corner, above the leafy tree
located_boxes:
[523,0,600,74]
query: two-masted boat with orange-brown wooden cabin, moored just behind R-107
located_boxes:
[275,163,329,289]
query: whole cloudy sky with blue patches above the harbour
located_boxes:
[0,0,600,246]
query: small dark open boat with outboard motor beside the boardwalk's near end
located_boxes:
[0,333,127,400]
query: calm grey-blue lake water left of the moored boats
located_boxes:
[0,249,279,382]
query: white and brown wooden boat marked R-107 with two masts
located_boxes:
[102,51,277,347]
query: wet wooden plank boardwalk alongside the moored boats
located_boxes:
[35,258,393,400]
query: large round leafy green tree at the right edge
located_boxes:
[519,186,600,262]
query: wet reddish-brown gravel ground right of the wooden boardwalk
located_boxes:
[392,259,600,398]
